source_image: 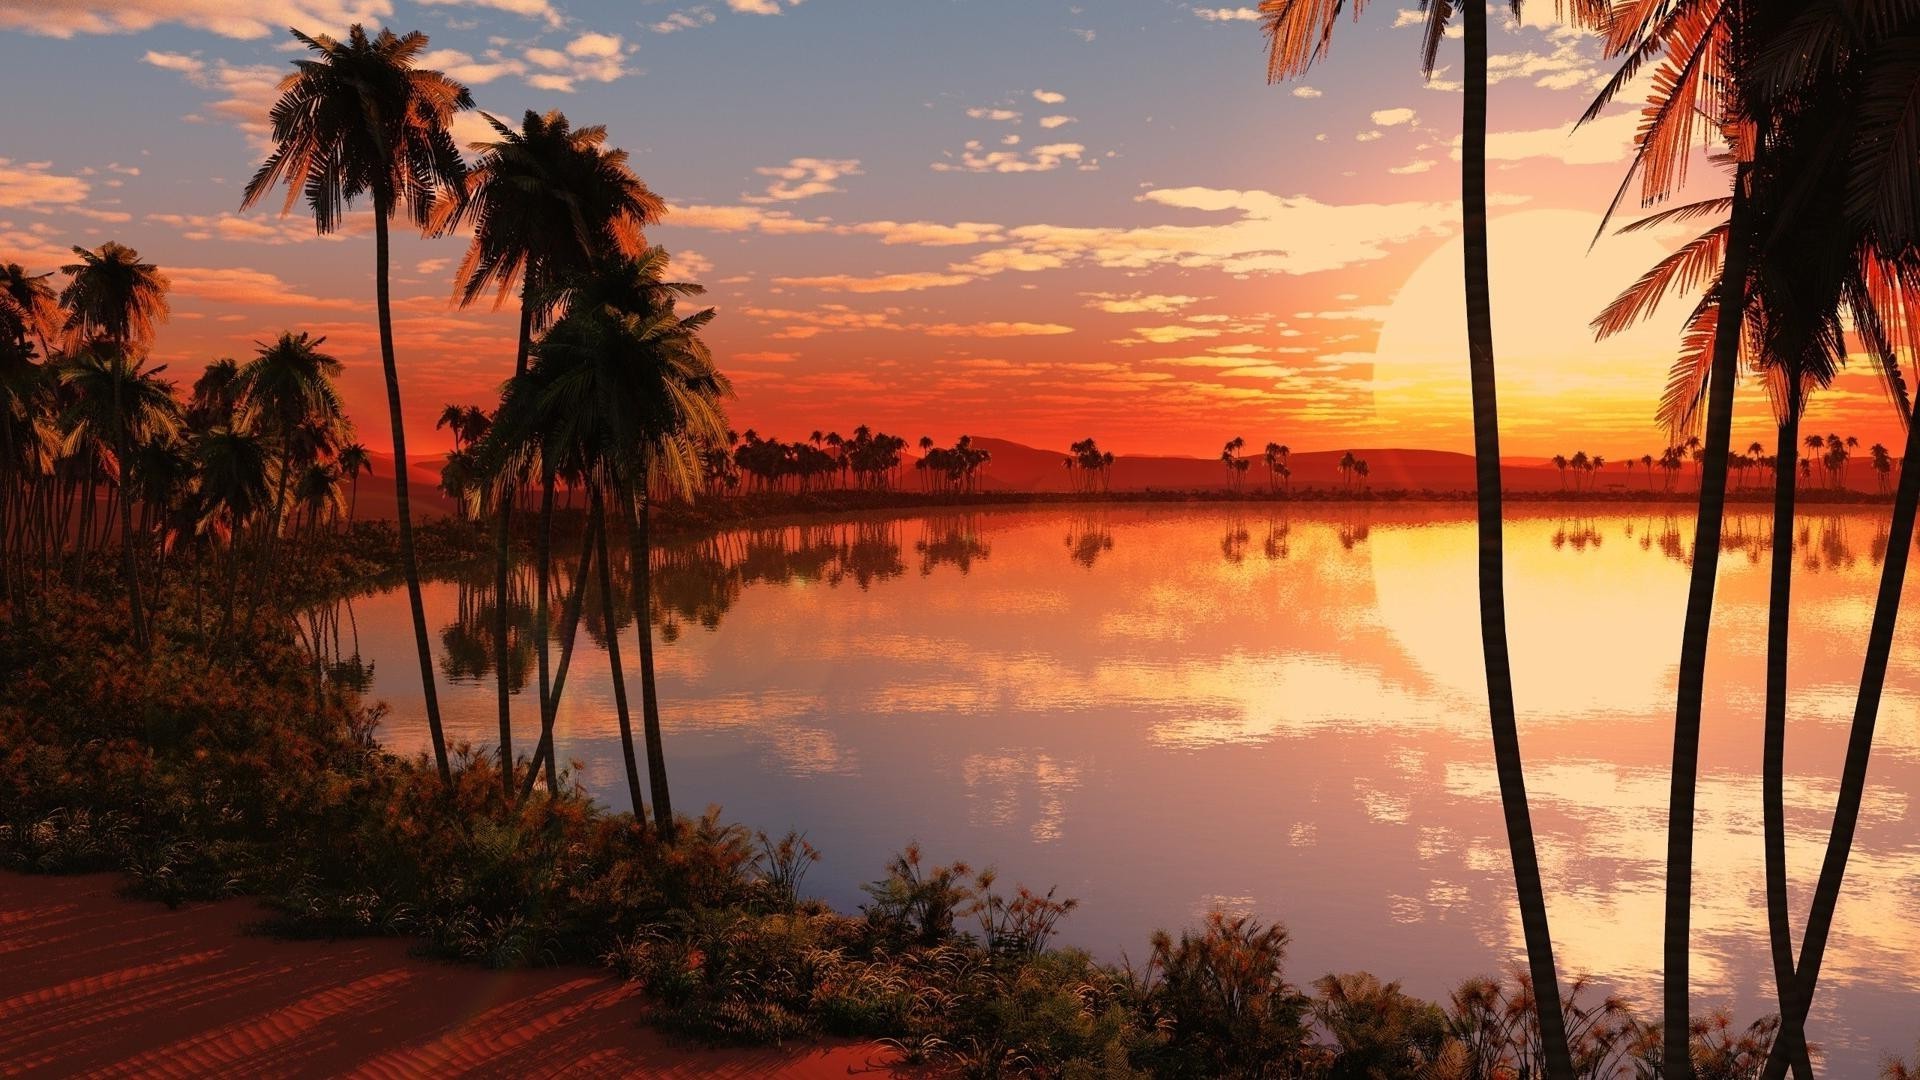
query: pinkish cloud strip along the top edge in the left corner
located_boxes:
[0,0,394,40]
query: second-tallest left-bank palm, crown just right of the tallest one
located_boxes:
[430,110,666,790]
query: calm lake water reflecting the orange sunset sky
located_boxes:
[348,505,1920,1074]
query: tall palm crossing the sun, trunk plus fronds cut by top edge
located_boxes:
[1260,0,1609,1080]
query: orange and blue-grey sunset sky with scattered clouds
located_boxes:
[0,0,1899,459]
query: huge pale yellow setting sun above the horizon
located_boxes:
[1373,209,1693,457]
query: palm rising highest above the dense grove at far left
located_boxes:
[60,240,169,651]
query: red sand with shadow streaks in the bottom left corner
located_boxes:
[0,872,910,1080]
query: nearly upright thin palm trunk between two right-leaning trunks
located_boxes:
[1761,411,1812,1080]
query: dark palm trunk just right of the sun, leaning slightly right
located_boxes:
[1661,165,1751,1080]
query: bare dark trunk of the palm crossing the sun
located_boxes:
[1459,4,1574,1080]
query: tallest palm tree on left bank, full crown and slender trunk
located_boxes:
[240,23,472,782]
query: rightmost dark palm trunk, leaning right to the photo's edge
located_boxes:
[1764,380,1920,1080]
